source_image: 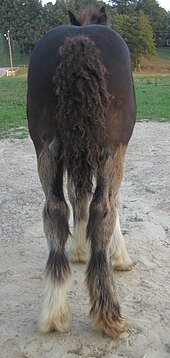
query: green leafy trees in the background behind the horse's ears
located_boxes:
[0,0,168,67]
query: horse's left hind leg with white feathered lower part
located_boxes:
[38,142,70,332]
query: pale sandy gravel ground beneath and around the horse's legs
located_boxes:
[0,122,170,358]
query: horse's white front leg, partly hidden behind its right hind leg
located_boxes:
[110,193,133,271]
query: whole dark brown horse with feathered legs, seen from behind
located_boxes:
[27,7,136,338]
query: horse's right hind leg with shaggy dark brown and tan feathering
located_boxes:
[86,146,127,338]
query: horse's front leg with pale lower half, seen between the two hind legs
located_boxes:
[67,179,90,263]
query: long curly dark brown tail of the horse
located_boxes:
[53,36,109,196]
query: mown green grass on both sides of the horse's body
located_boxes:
[0,73,170,138]
